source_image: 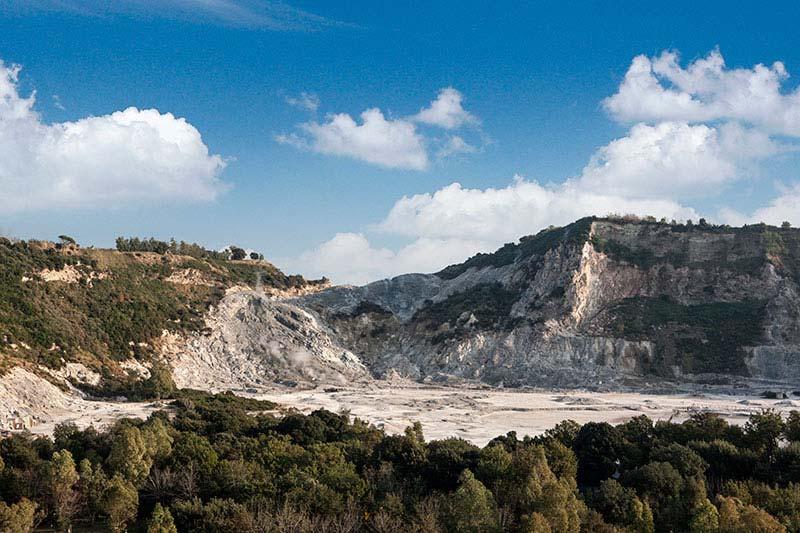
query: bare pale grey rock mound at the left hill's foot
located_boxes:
[170,290,368,389]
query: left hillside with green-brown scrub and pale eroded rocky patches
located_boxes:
[0,238,338,400]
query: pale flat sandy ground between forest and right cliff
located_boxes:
[255,387,800,446]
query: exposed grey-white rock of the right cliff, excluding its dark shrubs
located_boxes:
[296,221,800,386]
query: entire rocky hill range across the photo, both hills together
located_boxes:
[0,218,800,404]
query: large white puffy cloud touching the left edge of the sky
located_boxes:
[0,62,227,213]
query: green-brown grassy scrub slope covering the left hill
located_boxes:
[0,239,306,371]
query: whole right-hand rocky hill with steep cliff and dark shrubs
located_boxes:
[292,218,800,386]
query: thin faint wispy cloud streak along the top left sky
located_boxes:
[0,0,354,31]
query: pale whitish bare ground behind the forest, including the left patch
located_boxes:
[7,368,800,446]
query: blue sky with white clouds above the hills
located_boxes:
[0,0,800,282]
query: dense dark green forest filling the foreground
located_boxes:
[0,391,800,533]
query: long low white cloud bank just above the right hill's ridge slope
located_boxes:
[292,176,697,284]
